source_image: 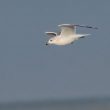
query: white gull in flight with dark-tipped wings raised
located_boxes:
[45,24,98,46]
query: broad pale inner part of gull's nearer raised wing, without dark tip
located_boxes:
[58,24,76,36]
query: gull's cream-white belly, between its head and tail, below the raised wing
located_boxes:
[56,37,76,45]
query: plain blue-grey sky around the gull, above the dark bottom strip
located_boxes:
[0,0,110,102]
